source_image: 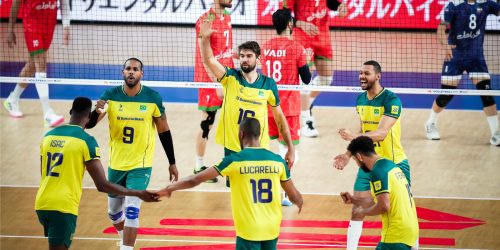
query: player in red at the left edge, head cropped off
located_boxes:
[4,0,70,127]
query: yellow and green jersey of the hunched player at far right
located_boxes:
[370,158,419,246]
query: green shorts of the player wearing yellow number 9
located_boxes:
[108,167,152,197]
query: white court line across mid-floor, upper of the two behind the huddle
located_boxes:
[0,184,500,201]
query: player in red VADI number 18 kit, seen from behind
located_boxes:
[260,9,311,206]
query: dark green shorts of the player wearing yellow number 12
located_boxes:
[36,210,77,248]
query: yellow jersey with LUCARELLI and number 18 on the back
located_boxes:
[215,147,290,241]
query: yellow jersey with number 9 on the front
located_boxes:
[100,85,165,171]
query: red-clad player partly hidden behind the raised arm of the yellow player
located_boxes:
[194,0,234,182]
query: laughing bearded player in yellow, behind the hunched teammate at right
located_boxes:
[334,61,410,249]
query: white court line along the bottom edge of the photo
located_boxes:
[0,235,485,250]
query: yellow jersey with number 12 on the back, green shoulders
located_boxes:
[35,125,99,215]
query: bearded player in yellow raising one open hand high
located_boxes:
[199,19,295,167]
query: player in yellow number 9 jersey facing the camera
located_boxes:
[87,58,178,250]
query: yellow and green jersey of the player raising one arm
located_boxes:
[215,68,280,152]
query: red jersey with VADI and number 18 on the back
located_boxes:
[261,37,307,116]
